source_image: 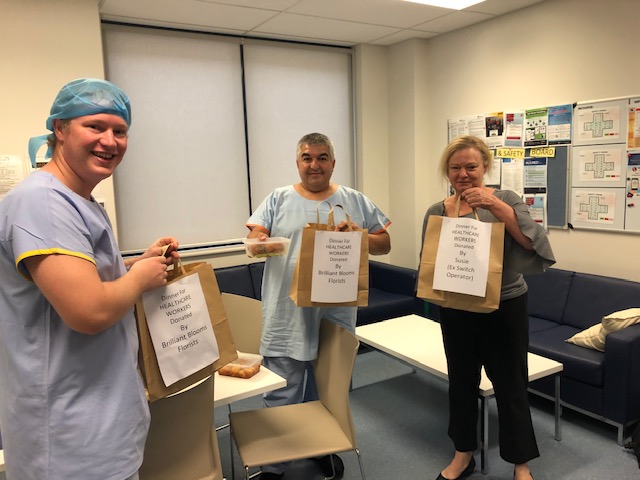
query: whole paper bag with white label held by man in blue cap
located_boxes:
[135,261,237,402]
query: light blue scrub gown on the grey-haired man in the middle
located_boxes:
[247,185,390,361]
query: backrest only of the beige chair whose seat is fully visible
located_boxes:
[315,319,360,448]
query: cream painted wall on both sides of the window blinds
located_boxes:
[5,0,640,281]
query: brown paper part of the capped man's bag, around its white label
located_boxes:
[135,262,238,402]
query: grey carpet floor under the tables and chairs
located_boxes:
[215,351,640,480]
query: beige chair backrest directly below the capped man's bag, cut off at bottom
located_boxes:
[140,375,223,480]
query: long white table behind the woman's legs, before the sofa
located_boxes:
[356,315,562,473]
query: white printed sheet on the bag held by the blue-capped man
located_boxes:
[142,275,220,387]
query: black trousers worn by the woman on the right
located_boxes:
[440,294,540,464]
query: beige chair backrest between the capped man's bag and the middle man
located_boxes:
[222,293,262,353]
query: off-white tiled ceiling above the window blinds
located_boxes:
[99,0,550,46]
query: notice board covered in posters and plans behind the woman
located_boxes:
[448,95,640,233]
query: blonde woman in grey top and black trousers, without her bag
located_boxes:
[423,136,555,480]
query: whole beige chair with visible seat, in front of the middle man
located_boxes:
[229,320,365,480]
